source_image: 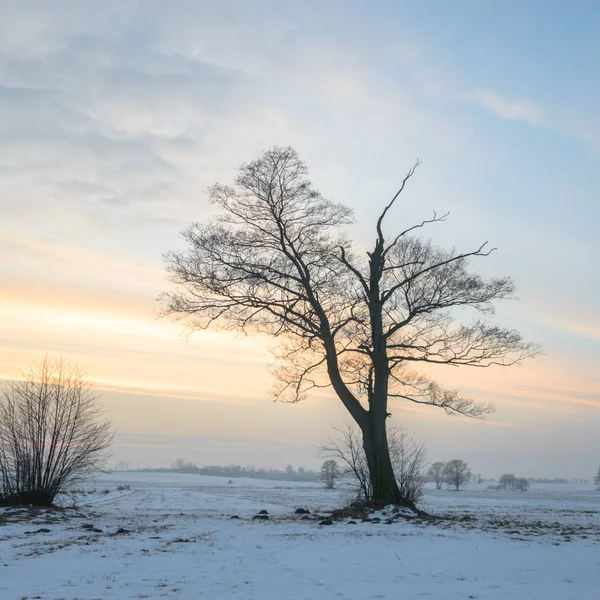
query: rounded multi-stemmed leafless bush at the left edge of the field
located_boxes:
[0,358,113,506]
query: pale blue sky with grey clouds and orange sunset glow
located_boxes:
[0,0,600,478]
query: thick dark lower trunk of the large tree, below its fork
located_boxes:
[362,414,408,506]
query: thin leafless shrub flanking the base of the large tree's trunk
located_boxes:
[321,422,426,505]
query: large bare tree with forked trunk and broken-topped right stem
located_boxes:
[161,147,538,503]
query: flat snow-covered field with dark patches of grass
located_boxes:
[0,473,600,600]
